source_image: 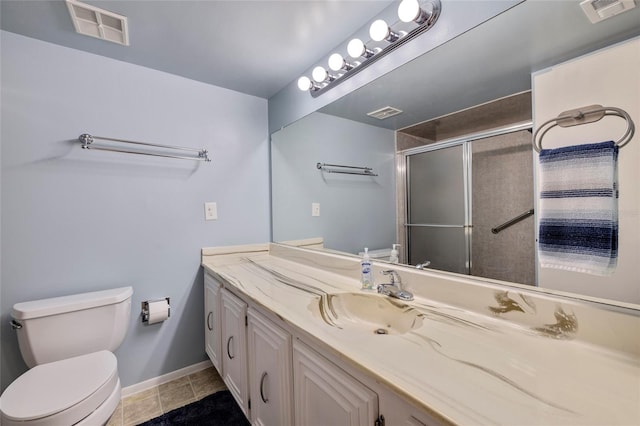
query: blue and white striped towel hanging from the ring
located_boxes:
[538,141,618,275]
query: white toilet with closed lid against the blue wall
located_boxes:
[0,287,133,426]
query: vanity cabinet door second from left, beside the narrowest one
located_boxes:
[222,289,249,417]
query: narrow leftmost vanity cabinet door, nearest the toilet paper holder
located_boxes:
[204,274,222,375]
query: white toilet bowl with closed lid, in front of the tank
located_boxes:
[0,351,120,426]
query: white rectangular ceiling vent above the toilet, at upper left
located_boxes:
[67,0,129,46]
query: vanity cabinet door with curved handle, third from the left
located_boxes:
[248,309,293,426]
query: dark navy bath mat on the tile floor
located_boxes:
[139,390,250,426]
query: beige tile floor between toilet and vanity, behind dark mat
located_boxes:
[107,367,227,426]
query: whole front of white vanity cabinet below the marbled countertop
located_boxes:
[205,273,442,426]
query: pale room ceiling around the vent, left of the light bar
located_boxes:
[0,0,393,99]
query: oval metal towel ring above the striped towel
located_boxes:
[533,105,636,152]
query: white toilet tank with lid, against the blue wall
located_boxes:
[11,287,133,368]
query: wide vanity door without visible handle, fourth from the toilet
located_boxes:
[293,340,378,426]
